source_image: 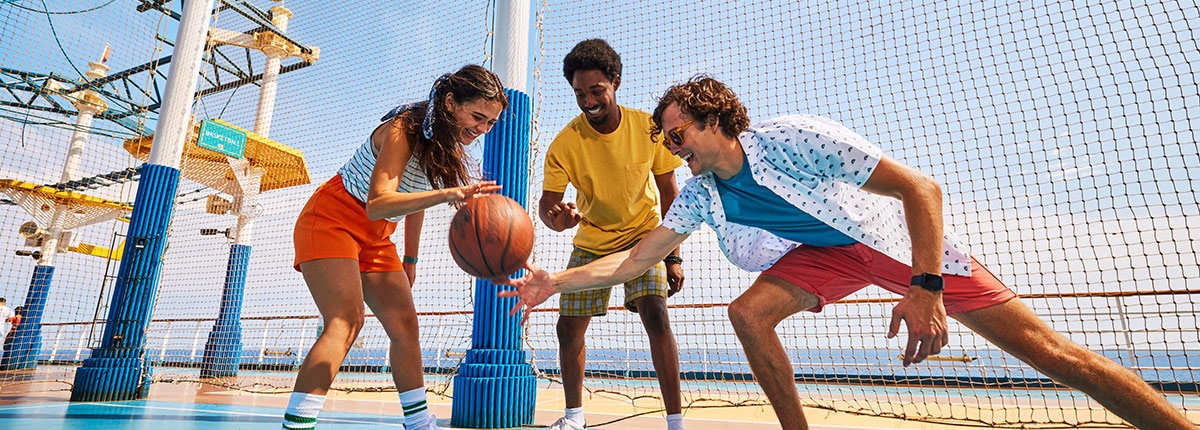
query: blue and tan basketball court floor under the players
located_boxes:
[0,371,993,430]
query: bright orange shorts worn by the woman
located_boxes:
[292,174,404,273]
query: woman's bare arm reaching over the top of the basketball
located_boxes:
[366,118,500,220]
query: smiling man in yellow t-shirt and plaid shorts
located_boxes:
[538,38,684,430]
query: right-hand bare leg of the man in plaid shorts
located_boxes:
[635,295,683,414]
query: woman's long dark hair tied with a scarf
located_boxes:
[392,65,509,189]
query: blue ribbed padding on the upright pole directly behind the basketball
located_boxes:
[450,89,538,429]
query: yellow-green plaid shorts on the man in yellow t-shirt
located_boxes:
[558,247,670,317]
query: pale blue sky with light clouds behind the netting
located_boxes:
[0,0,1200,362]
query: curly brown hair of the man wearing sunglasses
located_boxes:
[650,74,750,138]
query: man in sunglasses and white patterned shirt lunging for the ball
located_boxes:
[502,77,1194,429]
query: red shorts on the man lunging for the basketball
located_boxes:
[762,244,1016,315]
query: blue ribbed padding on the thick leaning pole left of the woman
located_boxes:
[71,165,179,401]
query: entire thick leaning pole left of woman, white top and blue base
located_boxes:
[71,0,215,401]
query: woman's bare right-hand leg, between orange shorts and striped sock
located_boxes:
[362,271,425,393]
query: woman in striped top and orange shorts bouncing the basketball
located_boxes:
[283,65,508,430]
